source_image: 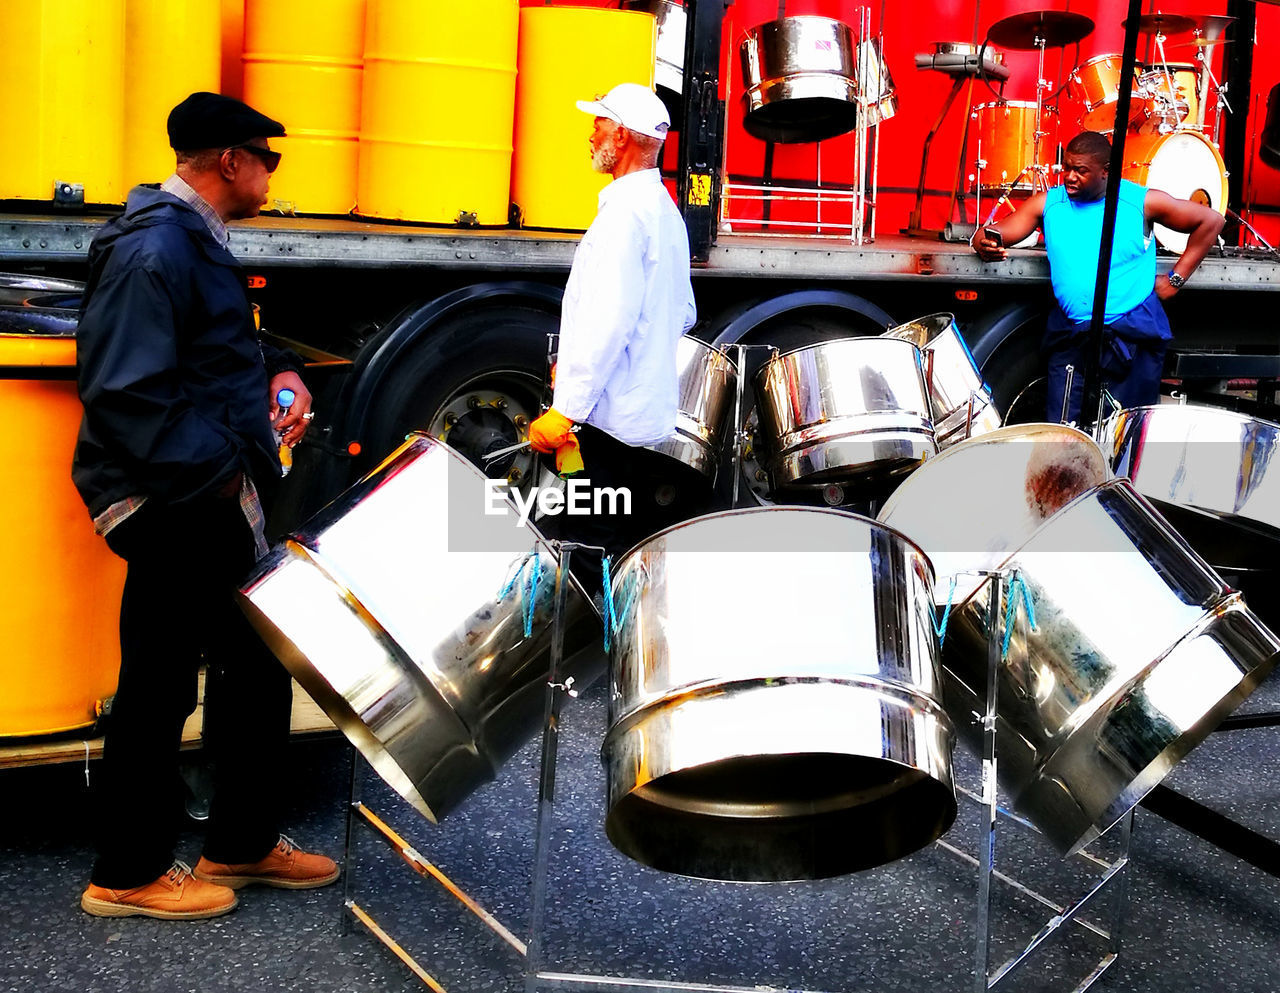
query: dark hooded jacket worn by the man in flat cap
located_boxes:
[72,187,301,516]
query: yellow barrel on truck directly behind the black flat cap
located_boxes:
[124,0,221,189]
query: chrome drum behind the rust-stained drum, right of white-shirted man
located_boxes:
[754,338,938,489]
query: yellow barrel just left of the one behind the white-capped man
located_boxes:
[356,0,520,224]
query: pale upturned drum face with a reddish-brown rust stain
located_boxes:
[878,424,1111,604]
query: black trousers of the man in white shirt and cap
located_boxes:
[544,424,709,596]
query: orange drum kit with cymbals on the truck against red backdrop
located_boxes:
[970,10,1234,253]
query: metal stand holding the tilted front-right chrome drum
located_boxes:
[937,569,1133,993]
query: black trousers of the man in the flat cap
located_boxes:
[92,499,292,889]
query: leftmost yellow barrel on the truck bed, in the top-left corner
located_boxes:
[0,0,125,203]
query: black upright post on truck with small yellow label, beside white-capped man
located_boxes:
[677,0,724,262]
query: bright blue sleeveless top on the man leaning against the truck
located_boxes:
[1043,179,1156,324]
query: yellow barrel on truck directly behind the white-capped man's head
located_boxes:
[511,6,658,230]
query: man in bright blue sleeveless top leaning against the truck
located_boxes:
[973,131,1222,421]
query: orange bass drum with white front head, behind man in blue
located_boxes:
[1120,131,1226,255]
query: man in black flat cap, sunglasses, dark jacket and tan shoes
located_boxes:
[72,93,338,920]
